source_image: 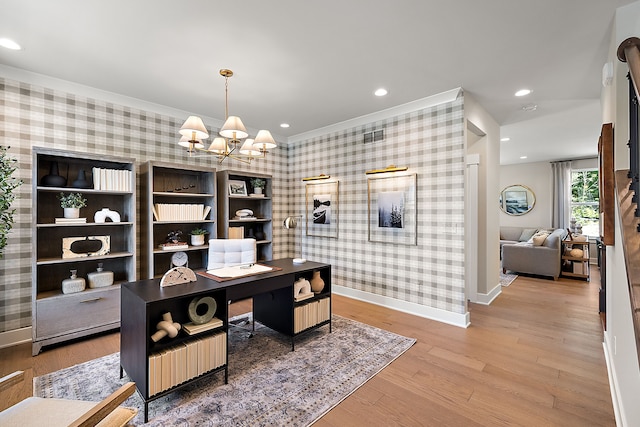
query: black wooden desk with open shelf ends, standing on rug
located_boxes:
[120,258,331,422]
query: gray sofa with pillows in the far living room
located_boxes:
[500,227,567,280]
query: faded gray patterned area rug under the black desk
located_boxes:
[34,315,416,426]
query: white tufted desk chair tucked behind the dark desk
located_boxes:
[207,239,257,338]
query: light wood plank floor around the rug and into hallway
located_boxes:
[0,268,615,427]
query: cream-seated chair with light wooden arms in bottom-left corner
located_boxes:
[0,371,138,427]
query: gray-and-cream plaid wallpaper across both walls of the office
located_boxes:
[0,78,465,332]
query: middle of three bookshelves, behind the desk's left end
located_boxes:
[141,161,217,279]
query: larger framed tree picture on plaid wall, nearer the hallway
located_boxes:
[367,174,418,245]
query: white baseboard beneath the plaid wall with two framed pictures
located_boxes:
[331,284,470,328]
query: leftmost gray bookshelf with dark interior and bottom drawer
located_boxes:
[31,147,136,356]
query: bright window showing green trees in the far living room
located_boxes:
[571,169,600,237]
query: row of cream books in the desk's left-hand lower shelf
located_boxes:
[148,332,227,396]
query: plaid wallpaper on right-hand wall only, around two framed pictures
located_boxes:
[288,98,466,314]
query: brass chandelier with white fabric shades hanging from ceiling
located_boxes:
[178,69,277,164]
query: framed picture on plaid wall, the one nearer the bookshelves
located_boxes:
[305,181,339,238]
